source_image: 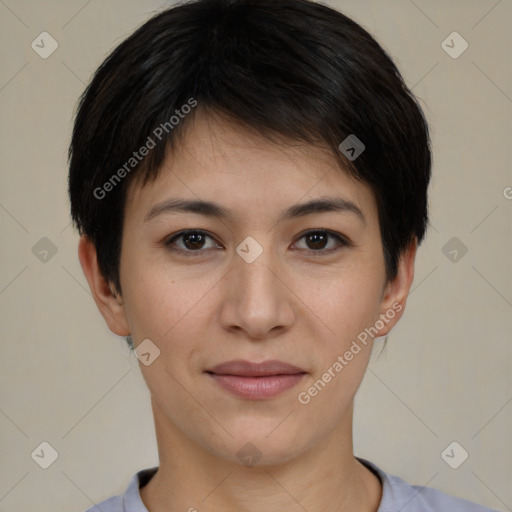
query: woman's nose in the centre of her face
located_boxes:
[220,246,295,341]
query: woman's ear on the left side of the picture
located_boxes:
[78,235,130,336]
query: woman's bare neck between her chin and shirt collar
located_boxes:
[140,402,382,512]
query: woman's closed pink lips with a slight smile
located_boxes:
[206,359,307,400]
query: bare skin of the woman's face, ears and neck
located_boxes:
[79,110,417,512]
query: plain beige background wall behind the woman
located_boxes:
[0,0,512,512]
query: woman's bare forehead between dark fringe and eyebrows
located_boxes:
[125,112,376,224]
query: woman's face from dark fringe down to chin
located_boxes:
[88,112,414,464]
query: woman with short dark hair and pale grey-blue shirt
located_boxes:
[69,0,498,512]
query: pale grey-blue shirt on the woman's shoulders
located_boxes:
[86,457,498,512]
